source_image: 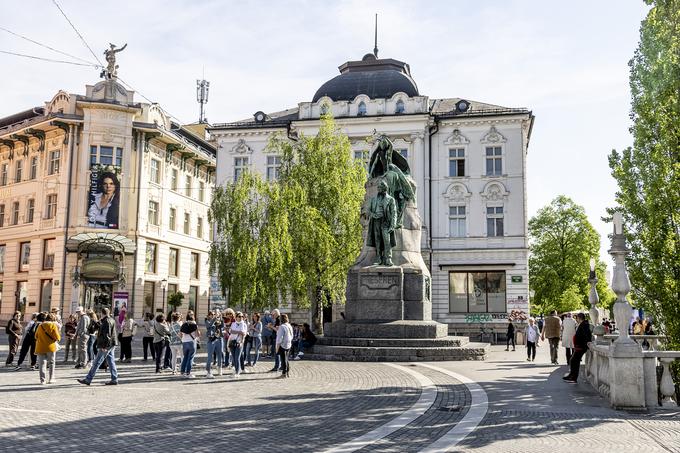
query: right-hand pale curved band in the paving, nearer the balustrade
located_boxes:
[418,363,489,453]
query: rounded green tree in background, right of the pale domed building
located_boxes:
[529,195,612,313]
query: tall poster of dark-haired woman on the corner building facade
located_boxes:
[87,164,120,230]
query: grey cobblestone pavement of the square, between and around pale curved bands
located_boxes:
[0,336,680,453]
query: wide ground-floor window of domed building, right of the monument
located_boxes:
[449,272,507,313]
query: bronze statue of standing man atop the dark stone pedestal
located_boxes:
[366,179,397,266]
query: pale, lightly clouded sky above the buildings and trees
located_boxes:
[0,0,649,272]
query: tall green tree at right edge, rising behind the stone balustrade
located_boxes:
[609,0,680,349]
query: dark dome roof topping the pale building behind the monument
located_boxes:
[312,54,419,102]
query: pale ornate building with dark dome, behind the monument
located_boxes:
[209,52,534,341]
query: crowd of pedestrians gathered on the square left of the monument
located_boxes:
[6,307,316,385]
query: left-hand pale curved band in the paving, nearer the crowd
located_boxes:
[324,363,437,453]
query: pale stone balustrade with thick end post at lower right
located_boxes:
[585,335,680,410]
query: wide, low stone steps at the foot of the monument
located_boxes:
[304,343,490,362]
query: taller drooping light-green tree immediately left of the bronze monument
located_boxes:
[269,116,366,332]
